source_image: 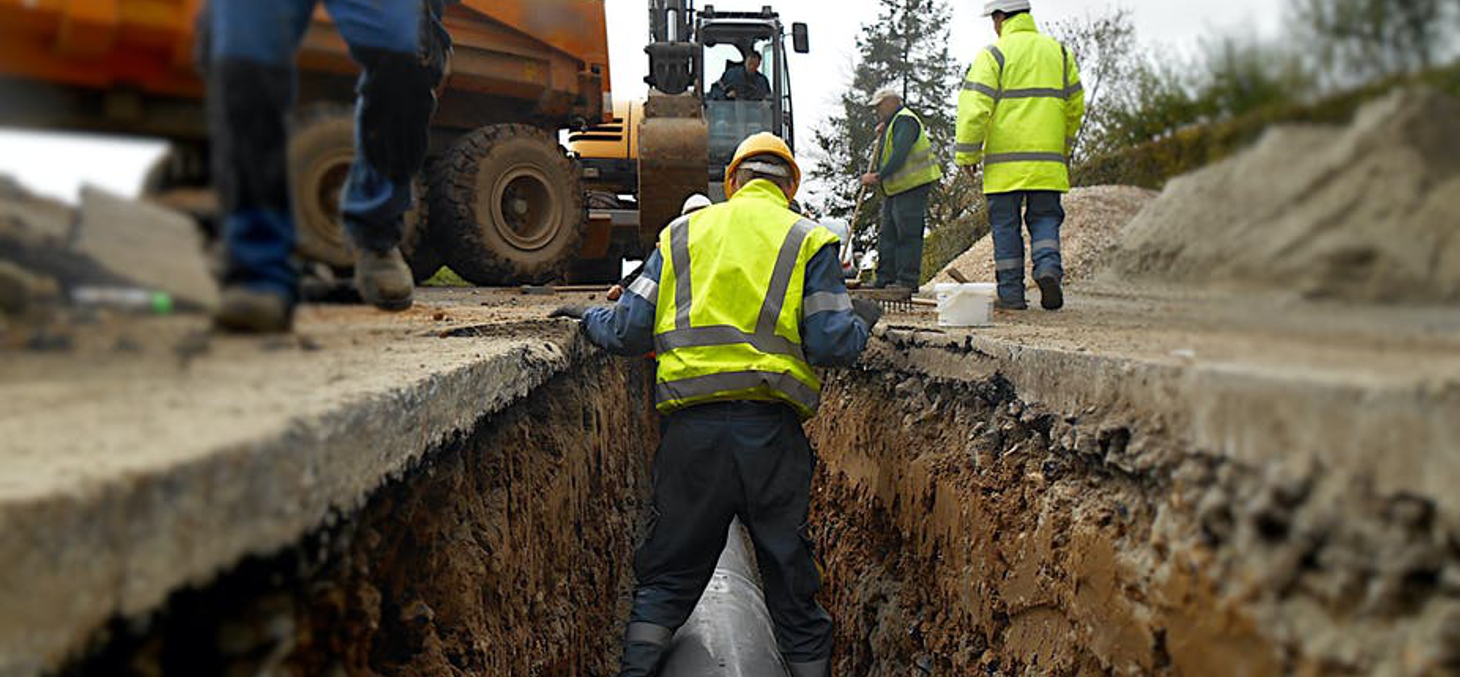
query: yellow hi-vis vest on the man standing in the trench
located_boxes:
[654,179,840,419]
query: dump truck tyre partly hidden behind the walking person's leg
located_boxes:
[289,105,441,282]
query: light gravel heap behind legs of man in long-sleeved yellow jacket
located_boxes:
[931,185,1156,286]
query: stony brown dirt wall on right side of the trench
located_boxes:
[810,371,1460,677]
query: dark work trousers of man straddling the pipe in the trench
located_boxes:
[619,403,832,677]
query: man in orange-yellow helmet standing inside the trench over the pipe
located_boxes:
[553,133,882,677]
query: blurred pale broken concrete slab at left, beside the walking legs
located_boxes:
[74,187,218,309]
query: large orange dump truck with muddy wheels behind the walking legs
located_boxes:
[0,0,621,283]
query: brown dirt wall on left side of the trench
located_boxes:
[64,353,657,677]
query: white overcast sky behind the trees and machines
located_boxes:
[0,0,1285,200]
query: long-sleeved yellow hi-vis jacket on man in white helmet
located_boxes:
[953,15,1085,194]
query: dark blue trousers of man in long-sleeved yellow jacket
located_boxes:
[987,191,1064,303]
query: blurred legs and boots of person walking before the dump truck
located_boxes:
[206,0,451,333]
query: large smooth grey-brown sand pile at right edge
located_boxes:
[1101,89,1460,303]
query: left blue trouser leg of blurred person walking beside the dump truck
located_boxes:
[207,0,314,302]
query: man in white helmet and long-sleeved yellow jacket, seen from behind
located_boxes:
[953,0,1085,311]
